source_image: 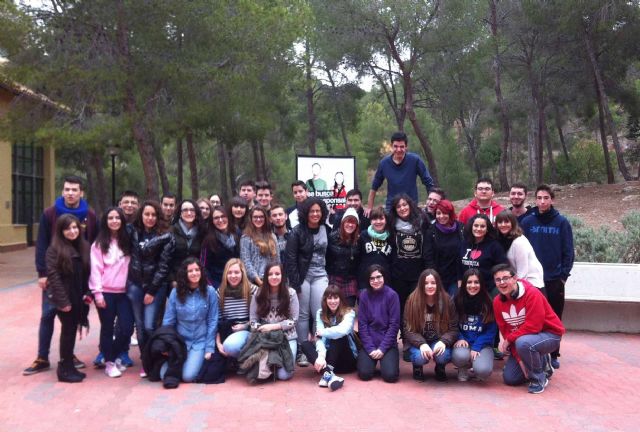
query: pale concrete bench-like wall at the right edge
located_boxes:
[562,263,640,333]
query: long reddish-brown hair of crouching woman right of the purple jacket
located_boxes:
[404,269,451,333]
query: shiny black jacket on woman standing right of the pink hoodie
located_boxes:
[127,225,175,295]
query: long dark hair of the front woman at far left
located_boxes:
[50,213,91,276]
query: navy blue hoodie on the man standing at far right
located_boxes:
[521,206,575,281]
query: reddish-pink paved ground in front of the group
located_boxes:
[0,249,640,432]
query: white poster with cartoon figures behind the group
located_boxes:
[296,155,356,211]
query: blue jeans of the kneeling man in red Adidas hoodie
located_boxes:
[502,332,562,385]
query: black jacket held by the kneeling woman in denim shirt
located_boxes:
[142,326,187,388]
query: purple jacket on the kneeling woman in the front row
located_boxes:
[358,285,400,353]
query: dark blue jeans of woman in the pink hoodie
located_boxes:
[97,293,133,362]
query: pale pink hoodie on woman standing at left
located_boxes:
[89,240,131,299]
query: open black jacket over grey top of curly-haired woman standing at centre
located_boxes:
[284,223,331,292]
